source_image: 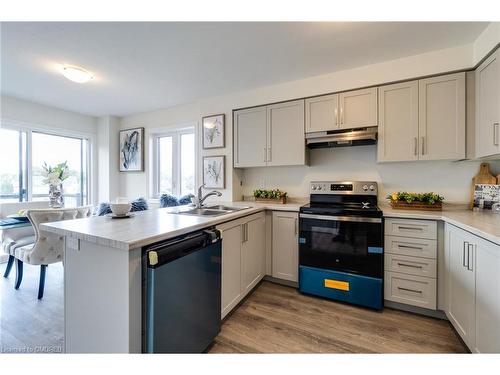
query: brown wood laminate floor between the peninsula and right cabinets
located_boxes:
[210,282,467,353]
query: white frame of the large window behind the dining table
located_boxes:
[0,120,97,205]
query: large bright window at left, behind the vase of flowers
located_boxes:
[0,129,90,207]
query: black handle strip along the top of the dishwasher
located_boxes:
[146,229,221,268]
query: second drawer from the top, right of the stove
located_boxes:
[384,236,437,259]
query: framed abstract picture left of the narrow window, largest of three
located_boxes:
[119,128,144,172]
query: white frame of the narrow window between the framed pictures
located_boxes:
[151,127,198,199]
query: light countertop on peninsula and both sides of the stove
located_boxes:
[42,201,500,250]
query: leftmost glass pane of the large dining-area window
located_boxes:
[0,129,26,202]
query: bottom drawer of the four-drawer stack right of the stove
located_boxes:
[384,271,436,310]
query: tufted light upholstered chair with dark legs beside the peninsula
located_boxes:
[8,206,92,299]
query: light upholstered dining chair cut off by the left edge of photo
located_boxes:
[0,201,49,277]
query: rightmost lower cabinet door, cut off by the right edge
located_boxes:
[475,239,500,353]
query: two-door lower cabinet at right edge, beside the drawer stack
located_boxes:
[445,224,500,353]
